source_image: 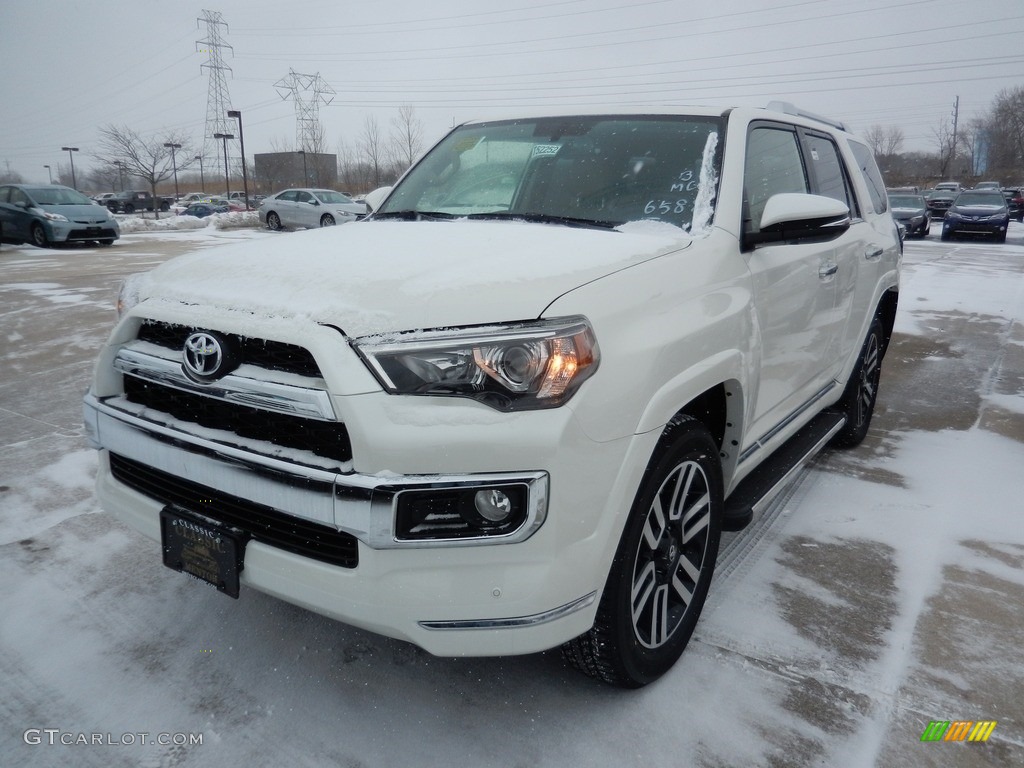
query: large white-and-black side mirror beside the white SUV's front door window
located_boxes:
[744,193,850,246]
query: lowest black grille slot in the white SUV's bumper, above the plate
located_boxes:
[111,454,359,568]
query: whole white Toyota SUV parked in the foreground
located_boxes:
[85,105,900,687]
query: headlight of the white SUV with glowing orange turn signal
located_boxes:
[352,317,600,411]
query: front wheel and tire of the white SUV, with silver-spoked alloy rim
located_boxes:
[562,417,724,688]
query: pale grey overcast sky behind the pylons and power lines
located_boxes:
[0,0,1024,185]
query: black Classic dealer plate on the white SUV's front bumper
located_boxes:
[160,507,248,598]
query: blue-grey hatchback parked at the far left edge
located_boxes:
[0,184,121,248]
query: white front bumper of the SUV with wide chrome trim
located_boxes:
[84,394,650,656]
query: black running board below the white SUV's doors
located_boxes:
[722,412,846,530]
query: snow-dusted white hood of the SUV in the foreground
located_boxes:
[137,219,691,336]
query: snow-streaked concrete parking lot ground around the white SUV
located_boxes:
[0,222,1024,768]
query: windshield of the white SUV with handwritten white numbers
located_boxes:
[378,116,721,230]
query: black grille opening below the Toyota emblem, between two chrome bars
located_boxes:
[124,375,352,462]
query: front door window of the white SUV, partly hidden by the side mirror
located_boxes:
[743,126,810,232]
